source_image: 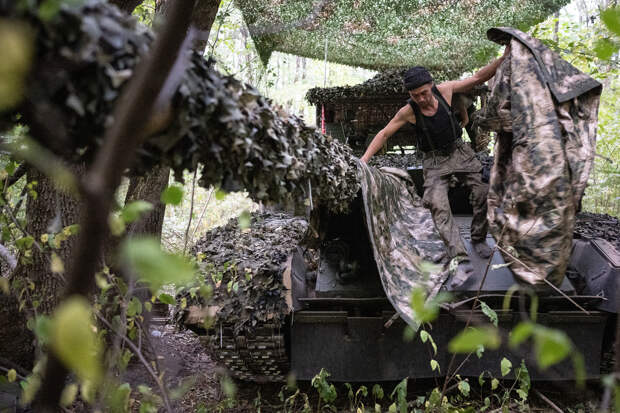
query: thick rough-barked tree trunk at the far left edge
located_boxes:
[0,166,84,368]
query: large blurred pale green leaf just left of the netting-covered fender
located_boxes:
[121,237,194,291]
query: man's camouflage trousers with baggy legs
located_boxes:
[423,145,489,258]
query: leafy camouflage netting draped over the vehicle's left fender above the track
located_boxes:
[183,211,308,332]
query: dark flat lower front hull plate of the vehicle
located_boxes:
[290,311,608,382]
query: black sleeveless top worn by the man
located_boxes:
[407,85,462,152]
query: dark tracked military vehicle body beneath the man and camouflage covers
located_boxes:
[186,157,620,382]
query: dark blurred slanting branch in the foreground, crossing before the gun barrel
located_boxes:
[35,0,195,413]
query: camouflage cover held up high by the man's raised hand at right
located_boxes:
[486,28,601,285]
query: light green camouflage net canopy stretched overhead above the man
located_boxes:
[240,0,568,77]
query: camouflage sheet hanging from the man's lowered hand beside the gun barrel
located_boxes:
[358,162,448,329]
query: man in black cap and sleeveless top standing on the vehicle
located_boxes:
[361,46,510,284]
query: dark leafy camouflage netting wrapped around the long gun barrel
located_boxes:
[0,1,359,211]
